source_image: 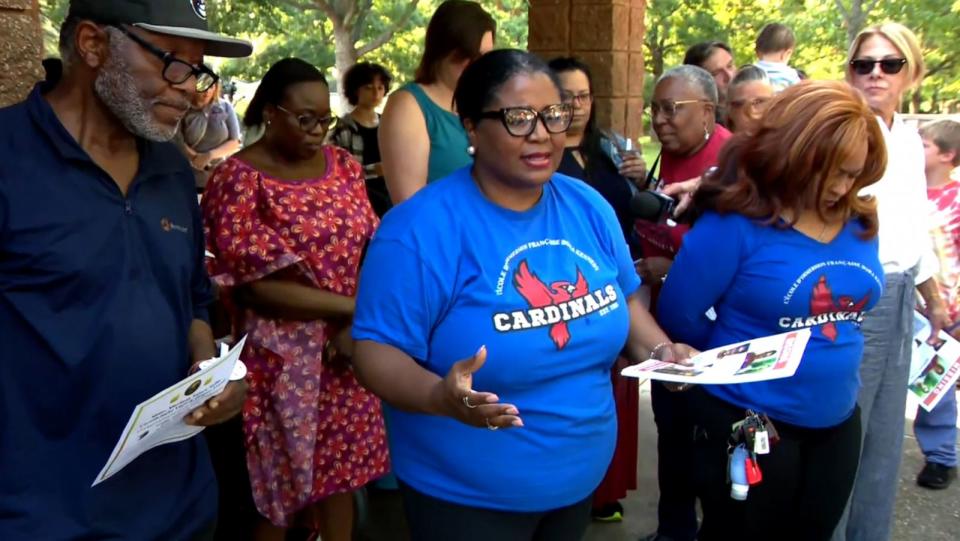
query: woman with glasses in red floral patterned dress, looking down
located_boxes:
[203,58,389,541]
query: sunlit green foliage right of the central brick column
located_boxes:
[644,0,960,112]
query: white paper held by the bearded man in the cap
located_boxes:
[91,337,247,486]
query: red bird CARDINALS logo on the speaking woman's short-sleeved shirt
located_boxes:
[493,260,618,350]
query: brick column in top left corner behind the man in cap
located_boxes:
[0,0,43,107]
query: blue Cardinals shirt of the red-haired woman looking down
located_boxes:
[657,212,883,428]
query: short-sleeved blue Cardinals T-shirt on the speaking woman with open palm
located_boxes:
[353,168,640,511]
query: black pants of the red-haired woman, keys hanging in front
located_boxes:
[689,388,860,541]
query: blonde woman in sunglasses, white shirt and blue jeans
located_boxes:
[837,23,950,541]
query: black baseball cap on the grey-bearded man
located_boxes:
[69,0,253,58]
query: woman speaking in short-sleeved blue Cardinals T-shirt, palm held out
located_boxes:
[353,50,692,541]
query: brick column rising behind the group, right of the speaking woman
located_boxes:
[528,0,647,137]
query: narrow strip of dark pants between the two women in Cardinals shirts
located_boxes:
[650,381,697,541]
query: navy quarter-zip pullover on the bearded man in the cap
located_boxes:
[0,89,217,541]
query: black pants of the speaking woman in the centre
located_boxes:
[400,481,592,541]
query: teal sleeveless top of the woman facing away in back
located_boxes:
[401,83,473,184]
